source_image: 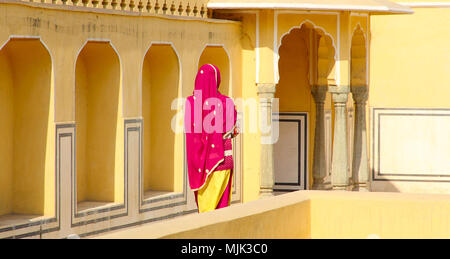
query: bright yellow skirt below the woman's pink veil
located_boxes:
[197,170,232,213]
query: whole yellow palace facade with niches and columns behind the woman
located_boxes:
[0,0,450,238]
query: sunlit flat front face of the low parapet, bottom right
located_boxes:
[309,193,450,239]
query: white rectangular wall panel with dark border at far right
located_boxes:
[371,108,450,182]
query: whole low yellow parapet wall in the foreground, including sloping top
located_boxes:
[97,191,450,239]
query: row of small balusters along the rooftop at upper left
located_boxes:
[22,0,208,18]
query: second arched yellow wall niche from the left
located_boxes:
[75,42,121,211]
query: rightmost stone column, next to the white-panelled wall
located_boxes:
[351,86,369,191]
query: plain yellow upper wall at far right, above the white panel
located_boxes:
[369,8,450,108]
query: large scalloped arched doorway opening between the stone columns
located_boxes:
[274,22,335,191]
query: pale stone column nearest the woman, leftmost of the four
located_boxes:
[257,84,275,198]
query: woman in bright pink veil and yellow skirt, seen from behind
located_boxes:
[185,64,237,213]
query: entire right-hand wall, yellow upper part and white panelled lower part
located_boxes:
[368,5,450,193]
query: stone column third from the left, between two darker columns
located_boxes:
[329,86,349,190]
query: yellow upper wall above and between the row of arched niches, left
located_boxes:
[0,3,241,122]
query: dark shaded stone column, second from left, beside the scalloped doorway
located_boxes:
[311,85,331,190]
